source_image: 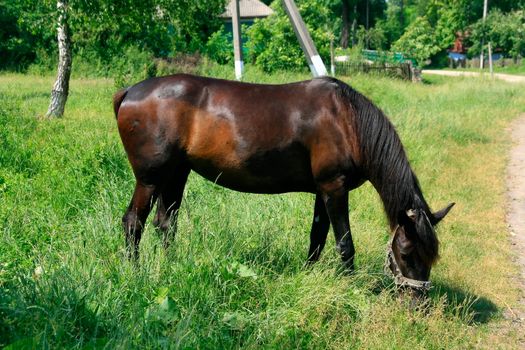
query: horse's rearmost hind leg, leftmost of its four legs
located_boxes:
[122,181,156,261]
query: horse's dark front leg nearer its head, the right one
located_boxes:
[320,176,355,271]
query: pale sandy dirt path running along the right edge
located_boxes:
[507,115,525,336]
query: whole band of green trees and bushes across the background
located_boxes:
[0,0,525,72]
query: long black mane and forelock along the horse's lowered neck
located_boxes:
[322,77,439,263]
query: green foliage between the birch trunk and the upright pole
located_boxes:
[72,0,225,57]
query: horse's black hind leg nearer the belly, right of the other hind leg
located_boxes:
[153,166,190,249]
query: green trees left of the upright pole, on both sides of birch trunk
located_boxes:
[0,0,226,71]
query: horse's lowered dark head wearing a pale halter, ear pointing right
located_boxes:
[386,203,454,299]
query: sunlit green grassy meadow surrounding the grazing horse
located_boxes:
[0,69,525,349]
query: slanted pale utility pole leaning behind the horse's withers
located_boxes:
[282,0,328,77]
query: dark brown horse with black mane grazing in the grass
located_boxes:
[113,74,454,294]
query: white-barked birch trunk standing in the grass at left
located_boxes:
[46,0,72,118]
